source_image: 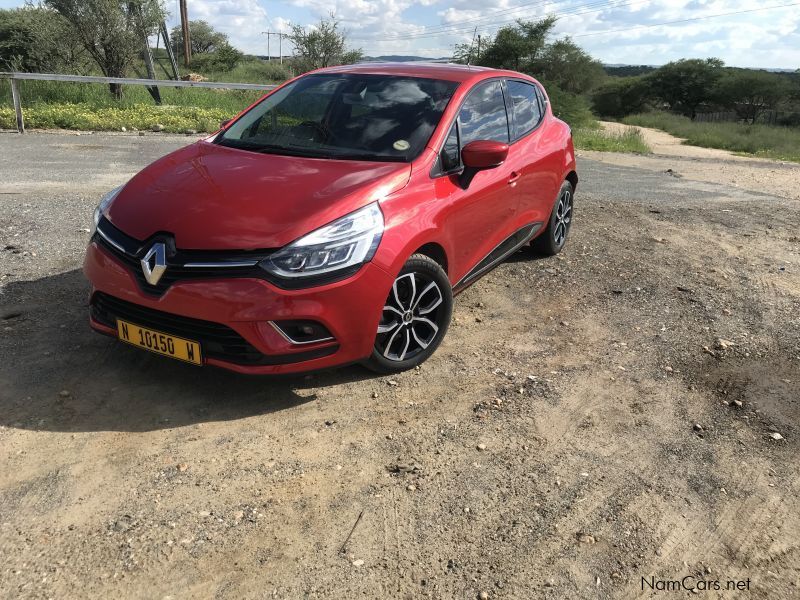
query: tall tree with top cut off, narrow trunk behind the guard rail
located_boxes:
[45,0,165,99]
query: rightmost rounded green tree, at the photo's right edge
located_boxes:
[716,69,792,123]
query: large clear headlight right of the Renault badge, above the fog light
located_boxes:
[259,202,383,280]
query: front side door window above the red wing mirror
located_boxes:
[458,81,509,148]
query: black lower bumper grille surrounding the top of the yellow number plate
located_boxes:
[91,292,339,366]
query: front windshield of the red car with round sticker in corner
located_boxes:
[216,73,458,162]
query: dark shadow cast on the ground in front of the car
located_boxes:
[0,269,375,432]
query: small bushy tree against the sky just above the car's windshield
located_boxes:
[288,15,364,71]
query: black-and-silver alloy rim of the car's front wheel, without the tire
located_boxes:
[375,271,446,362]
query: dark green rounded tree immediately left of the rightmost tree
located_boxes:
[647,58,724,119]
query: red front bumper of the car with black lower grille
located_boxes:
[83,242,393,374]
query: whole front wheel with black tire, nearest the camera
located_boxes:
[365,254,453,374]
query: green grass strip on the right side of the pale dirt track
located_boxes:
[623,112,800,162]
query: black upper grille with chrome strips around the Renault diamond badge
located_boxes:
[93,217,274,296]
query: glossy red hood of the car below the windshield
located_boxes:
[106,141,411,250]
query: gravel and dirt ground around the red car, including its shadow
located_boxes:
[0,133,800,599]
